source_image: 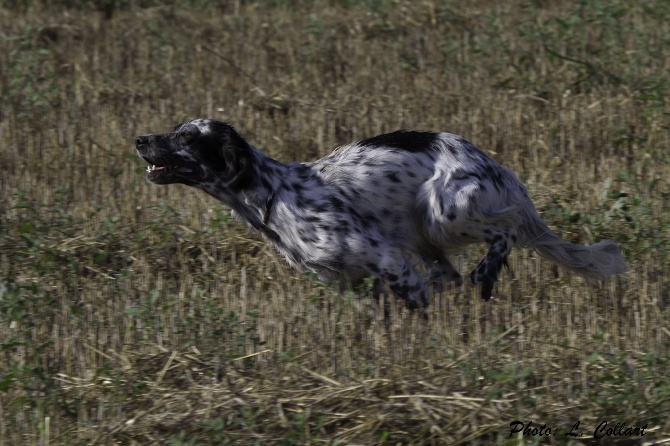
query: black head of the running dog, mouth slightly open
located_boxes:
[135,119,253,189]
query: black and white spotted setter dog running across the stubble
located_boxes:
[135,119,627,309]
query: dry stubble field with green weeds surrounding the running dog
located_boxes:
[0,0,670,446]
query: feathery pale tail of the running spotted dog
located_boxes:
[518,206,628,280]
